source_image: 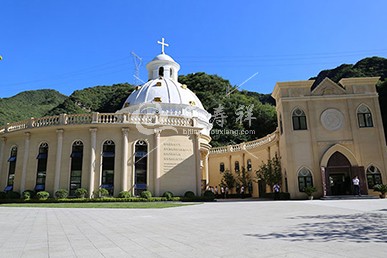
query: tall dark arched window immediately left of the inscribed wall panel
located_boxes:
[134,140,148,195]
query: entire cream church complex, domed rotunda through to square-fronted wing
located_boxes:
[0,39,387,199]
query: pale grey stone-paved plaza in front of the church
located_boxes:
[0,199,387,258]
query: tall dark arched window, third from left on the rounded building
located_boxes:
[69,141,83,196]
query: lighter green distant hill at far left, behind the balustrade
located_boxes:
[0,90,67,125]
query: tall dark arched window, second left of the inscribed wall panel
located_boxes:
[101,140,115,195]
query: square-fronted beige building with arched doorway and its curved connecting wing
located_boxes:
[208,75,387,199]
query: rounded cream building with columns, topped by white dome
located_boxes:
[0,45,212,197]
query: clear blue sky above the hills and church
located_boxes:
[0,0,387,98]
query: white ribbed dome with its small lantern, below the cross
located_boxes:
[117,50,212,135]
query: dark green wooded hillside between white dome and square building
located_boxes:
[179,73,277,146]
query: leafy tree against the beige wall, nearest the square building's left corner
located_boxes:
[255,154,282,189]
